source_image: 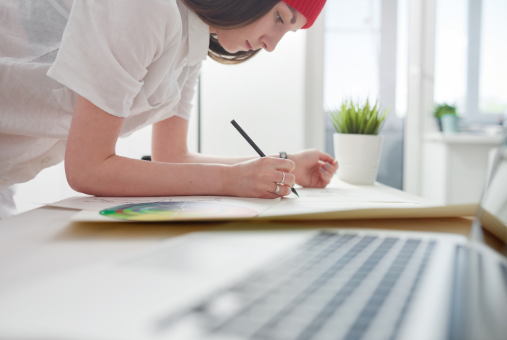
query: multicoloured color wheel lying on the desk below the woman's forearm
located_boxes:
[100,201,258,221]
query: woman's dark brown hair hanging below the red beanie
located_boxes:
[182,0,280,64]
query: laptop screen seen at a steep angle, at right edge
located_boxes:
[479,129,507,241]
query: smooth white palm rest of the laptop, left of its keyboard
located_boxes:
[0,232,312,339]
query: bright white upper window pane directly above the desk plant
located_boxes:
[324,0,381,107]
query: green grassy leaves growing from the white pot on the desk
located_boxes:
[329,99,389,135]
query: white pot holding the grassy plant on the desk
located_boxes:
[333,133,384,185]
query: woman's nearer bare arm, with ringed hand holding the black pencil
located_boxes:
[65,97,294,198]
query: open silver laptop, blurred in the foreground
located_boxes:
[0,131,507,340]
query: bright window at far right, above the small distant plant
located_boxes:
[434,0,507,124]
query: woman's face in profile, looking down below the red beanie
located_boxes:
[210,1,306,53]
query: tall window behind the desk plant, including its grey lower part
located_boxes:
[324,0,408,189]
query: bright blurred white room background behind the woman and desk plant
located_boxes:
[15,0,507,212]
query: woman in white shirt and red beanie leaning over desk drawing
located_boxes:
[0,0,338,215]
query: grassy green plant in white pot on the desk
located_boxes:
[330,99,389,185]
